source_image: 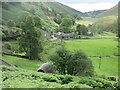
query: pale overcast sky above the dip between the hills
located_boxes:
[57,0,119,12]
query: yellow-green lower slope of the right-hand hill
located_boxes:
[89,16,118,34]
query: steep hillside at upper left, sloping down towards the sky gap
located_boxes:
[2,2,86,31]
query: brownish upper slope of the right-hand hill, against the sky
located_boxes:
[97,5,118,17]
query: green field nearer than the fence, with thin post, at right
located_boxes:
[91,56,118,76]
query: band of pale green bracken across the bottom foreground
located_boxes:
[1,66,118,89]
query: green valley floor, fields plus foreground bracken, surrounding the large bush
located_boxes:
[2,39,118,88]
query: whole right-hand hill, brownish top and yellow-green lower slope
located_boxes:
[89,5,118,34]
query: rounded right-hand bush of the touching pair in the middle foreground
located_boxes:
[67,50,93,76]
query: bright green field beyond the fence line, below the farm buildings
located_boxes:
[65,39,118,56]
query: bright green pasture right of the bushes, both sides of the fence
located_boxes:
[65,39,118,76]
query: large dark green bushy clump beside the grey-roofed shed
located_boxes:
[50,48,93,76]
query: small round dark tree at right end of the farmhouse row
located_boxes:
[76,24,88,35]
